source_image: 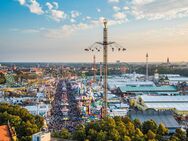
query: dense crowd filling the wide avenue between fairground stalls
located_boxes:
[48,80,83,131]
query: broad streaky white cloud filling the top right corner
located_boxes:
[132,0,188,20]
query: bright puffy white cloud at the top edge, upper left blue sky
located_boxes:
[27,0,44,15]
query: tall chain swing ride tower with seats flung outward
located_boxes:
[85,19,126,118]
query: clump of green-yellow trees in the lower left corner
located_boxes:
[0,103,44,141]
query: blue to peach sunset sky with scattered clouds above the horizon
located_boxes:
[0,0,188,62]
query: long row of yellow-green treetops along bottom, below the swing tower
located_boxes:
[52,116,188,141]
